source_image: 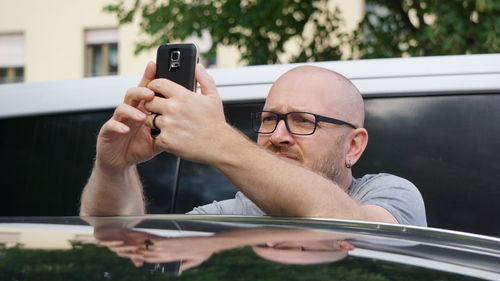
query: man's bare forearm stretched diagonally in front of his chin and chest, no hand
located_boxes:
[214,124,365,220]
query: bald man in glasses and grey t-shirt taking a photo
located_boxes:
[81,63,426,226]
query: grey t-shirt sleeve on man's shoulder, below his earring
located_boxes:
[351,174,427,226]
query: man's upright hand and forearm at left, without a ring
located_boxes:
[80,62,161,216]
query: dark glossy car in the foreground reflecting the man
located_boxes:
[0,215,500,280]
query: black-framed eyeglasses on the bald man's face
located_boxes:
[252,111,357,136]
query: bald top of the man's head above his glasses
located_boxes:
[266,65,365,127]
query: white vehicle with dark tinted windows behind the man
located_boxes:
[0,54,500,236]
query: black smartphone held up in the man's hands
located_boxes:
[151,43,198,136]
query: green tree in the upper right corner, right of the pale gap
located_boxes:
[352,0,500,58]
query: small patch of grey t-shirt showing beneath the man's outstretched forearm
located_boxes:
[187,192,265,216]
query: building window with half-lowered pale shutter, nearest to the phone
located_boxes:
[85,29,118,76]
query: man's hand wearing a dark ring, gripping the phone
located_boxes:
[145,65,229,163]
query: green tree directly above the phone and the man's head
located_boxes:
[105,0,347,64]
